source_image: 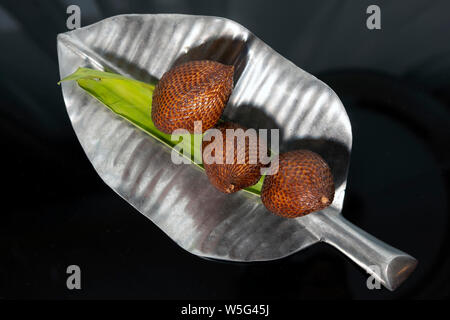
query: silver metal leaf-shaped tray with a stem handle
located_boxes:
[58,14,416,290]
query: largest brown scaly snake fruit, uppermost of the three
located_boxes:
[151,60,234,134]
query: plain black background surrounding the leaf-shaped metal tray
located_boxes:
[0,0,450,299]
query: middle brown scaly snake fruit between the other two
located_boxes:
[202,122,261,193]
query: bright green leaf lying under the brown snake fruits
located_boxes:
[60,68,264,195]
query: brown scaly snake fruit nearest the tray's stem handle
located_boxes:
[261,150,334,218]
